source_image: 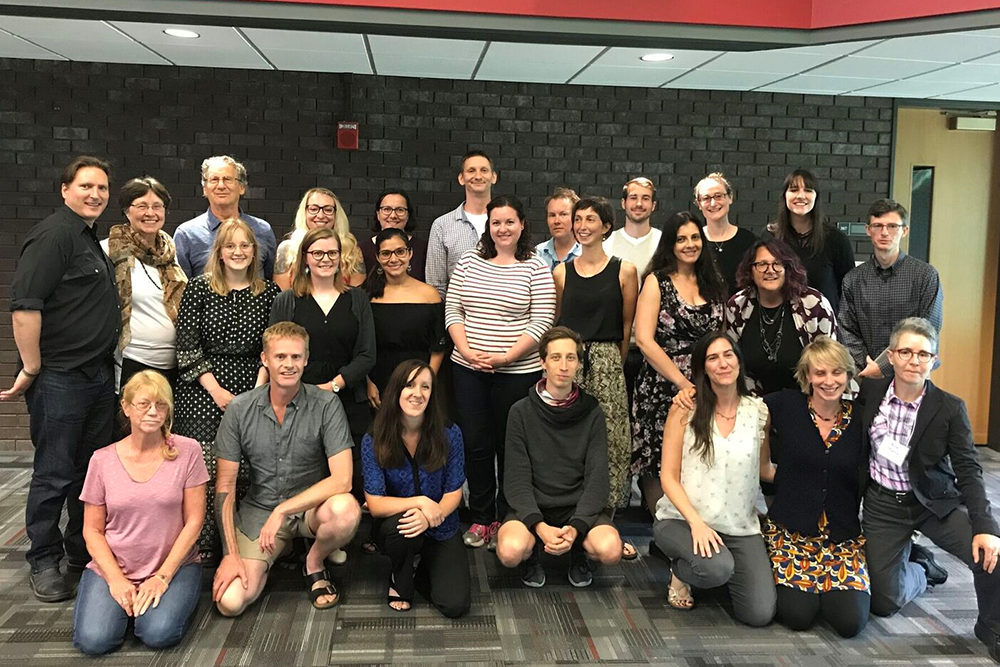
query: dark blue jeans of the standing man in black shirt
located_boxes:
[24,362,115,572]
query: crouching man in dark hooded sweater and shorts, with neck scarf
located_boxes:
[497,327,622,588]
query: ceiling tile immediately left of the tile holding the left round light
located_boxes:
[3,16,167,65]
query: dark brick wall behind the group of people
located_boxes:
[0,59,893,450]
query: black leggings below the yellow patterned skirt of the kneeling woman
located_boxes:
[777,585,872,637]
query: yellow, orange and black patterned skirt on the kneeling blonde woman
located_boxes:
[764,512,871,594]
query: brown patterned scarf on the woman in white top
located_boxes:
[108,224,187,350]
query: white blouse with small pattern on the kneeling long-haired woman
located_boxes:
[656,396,767,536]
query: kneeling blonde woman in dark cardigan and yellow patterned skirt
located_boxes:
[764,336,871,637]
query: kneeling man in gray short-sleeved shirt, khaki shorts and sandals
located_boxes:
[212,322,361,616]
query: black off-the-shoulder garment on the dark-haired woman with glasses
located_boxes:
[368,302,447,394]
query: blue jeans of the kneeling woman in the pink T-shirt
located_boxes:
[73,563,201,655]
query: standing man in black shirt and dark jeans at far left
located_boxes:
[0,156,121,602]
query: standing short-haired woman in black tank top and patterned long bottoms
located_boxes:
[552,197,639,560]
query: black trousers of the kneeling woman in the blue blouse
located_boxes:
[374,513,472,618]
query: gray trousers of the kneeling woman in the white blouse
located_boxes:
[653,519,777,627]
